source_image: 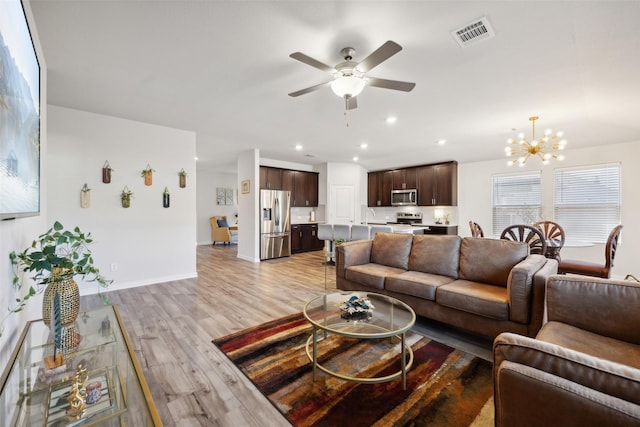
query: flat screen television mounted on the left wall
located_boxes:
[0,0,40,220]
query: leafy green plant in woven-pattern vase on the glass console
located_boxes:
[0,221,112,334]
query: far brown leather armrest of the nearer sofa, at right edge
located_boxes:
[546,275,640,344]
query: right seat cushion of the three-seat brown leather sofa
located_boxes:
[436,280,509,320]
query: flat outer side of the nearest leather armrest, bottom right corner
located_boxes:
[494,361,640,427]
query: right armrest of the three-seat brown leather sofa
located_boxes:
[507,255,547,324]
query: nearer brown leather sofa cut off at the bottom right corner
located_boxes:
[493,275,640,427]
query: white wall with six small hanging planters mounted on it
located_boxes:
[47,106,197,294]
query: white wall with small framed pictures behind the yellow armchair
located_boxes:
[196,169,238,245]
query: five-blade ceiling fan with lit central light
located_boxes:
[289,40,416,110]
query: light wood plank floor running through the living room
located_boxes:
[82,245,491,427]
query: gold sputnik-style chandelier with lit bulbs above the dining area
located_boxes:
[504,116,567,166]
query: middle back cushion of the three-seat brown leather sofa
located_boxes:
[409,234,462,279]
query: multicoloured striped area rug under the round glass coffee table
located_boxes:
[213,313,493,427]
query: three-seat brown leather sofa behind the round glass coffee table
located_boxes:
[336,233,558,338]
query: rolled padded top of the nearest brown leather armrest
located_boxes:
[493,332,640,405]
